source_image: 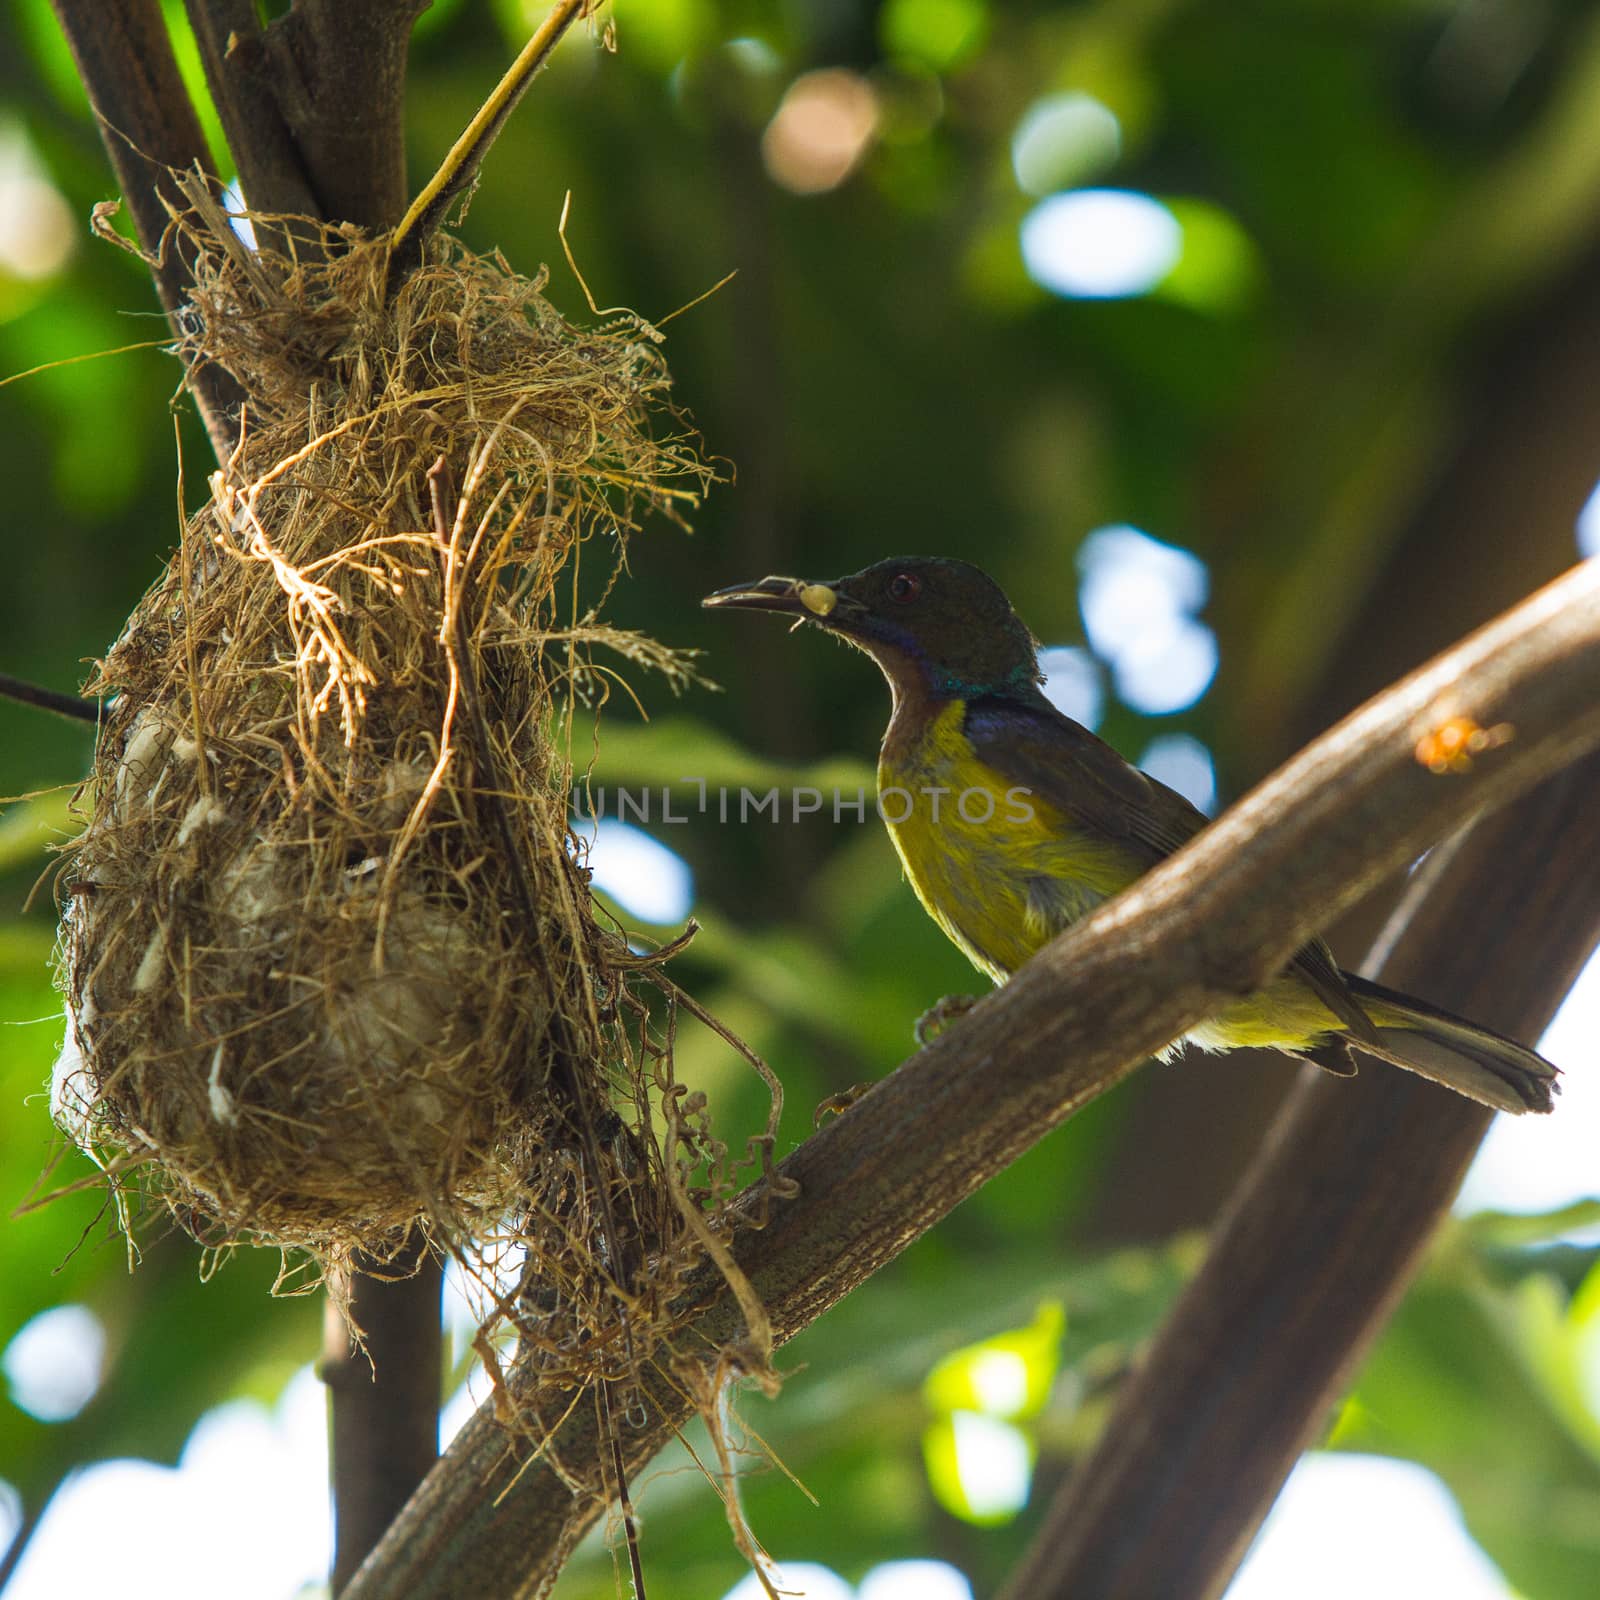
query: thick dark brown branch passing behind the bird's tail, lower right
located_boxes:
[1006,757,1600,1600]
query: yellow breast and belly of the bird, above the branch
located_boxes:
[878,704,1139,984]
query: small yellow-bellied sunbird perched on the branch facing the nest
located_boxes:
[704,557,1557,1112]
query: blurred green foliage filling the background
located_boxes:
[0,0,1600,1600]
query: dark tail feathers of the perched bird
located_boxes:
[1344,973,1560,1112]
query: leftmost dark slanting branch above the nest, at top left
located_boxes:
[51,0,242,461]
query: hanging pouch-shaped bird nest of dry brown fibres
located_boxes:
[54,179,770,1395]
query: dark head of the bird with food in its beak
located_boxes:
[701,555,1040,699]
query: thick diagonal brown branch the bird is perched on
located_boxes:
[347,563,1600,1600]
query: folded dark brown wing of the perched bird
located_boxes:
[963,699,1378,1040]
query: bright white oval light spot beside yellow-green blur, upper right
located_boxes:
[1021,189,1184,299]
